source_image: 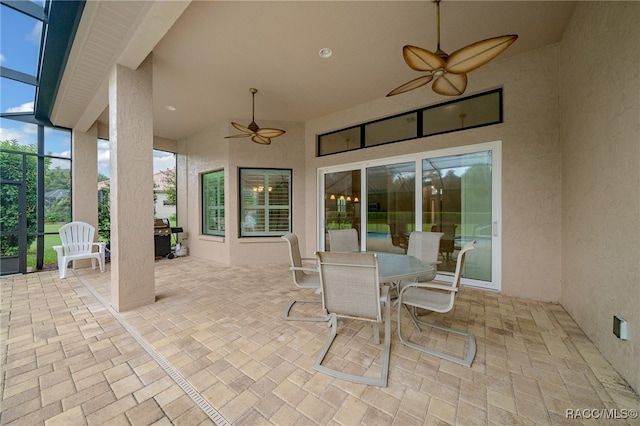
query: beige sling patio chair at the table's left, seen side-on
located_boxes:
[282,233,329,322]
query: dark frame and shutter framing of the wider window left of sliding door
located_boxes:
[238,167,293,238]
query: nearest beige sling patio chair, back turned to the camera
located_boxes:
[313,252,391,387]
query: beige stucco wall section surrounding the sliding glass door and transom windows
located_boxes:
[306,45,562,301]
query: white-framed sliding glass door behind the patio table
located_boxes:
[319,142,500,290]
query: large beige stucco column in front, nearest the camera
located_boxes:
[109,55,155,312]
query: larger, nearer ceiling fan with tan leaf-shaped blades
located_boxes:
[387,0,518,96]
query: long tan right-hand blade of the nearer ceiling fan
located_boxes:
[445,35,518,74]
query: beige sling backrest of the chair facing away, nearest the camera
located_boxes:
[318,252,382,322]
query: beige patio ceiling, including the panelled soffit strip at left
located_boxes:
[52,0,576,140]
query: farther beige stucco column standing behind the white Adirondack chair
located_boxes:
[71,124,98,268]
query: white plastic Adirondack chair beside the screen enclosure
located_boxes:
[53,222,106,278]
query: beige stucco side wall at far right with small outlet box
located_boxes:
[560,2,640,392]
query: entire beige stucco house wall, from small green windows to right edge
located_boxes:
[170,2,640,391]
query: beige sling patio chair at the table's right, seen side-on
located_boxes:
[398,241,476,367]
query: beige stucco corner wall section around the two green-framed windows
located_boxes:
[178,118,306,265]
